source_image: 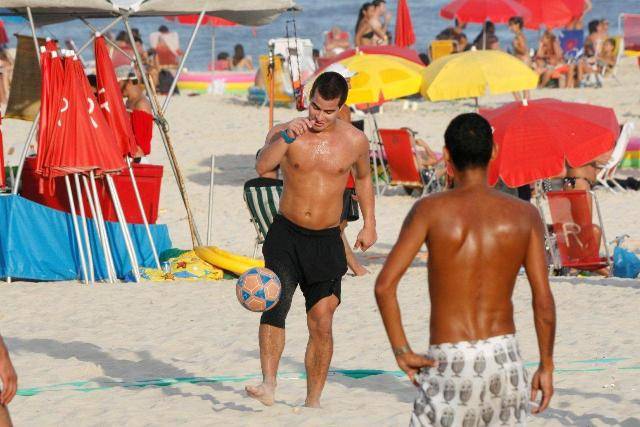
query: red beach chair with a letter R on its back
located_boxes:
[540,190,611,271]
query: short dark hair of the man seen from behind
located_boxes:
[444,113,493,171]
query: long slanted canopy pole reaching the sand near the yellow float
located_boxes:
[124,17,202,247]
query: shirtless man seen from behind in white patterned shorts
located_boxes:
[375,113,555,426]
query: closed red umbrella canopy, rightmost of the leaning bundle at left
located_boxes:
[95,36,136,157]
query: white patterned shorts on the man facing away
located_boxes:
[411,335,530,427]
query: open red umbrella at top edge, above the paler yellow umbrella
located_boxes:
[440,0,531,24]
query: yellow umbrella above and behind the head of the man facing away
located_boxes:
[420,50,538,101]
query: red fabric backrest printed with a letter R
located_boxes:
[547,190,604,270]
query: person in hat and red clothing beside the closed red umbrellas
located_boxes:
[116,65,153,162]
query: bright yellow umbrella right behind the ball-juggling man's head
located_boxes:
[340,53,425,105]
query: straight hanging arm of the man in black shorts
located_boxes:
[354,133,378,252]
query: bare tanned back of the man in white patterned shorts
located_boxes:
[419,187,537,344]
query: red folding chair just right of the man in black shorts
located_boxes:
[379,129,439,194]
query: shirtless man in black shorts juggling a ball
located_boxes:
[246,72,376,407]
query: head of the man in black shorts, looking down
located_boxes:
[309,71,349,132]
